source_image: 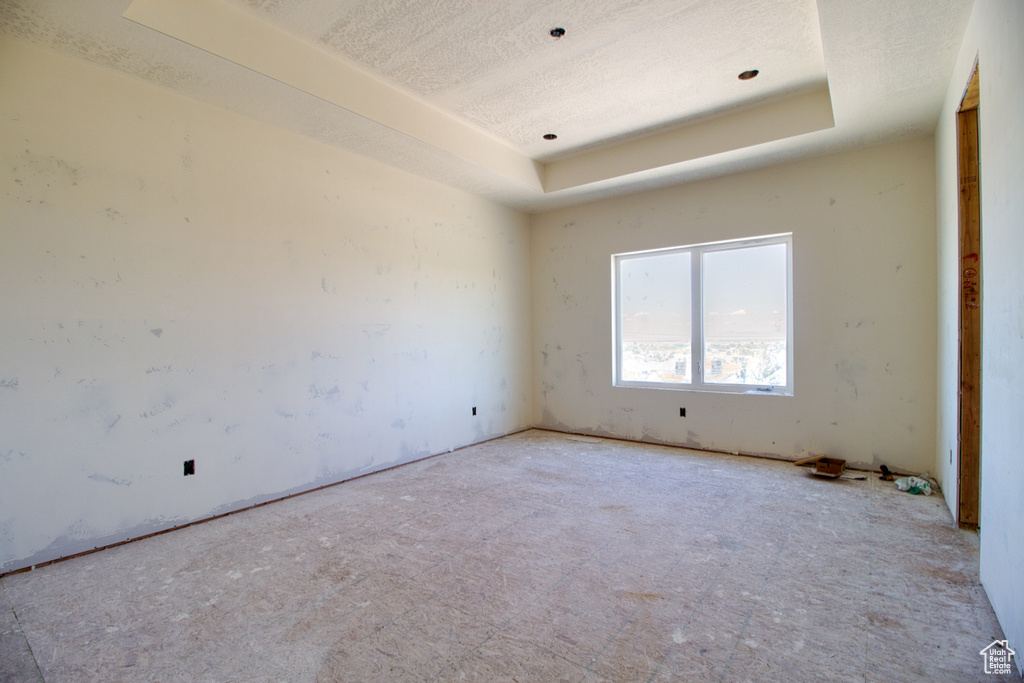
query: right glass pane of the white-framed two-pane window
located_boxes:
[703,244,787,386]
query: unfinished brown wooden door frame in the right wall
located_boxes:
[956,61,982,528]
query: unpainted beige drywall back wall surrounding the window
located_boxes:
[530,138,936,472]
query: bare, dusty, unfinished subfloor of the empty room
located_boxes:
[0,431,1011,683]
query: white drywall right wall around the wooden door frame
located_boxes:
[935,0,1024,671]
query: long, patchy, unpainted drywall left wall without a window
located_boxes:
[0,38,531,571]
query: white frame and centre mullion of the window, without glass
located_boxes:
[611,232,794,396]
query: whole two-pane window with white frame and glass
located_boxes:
[611,234,793,394]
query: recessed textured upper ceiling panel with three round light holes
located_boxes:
[232,0,825,160]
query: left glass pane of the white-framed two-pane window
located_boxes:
[618,252,692,384]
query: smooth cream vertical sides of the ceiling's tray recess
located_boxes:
[123,0,835,194]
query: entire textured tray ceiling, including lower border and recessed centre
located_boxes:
[0,0,973,211]
